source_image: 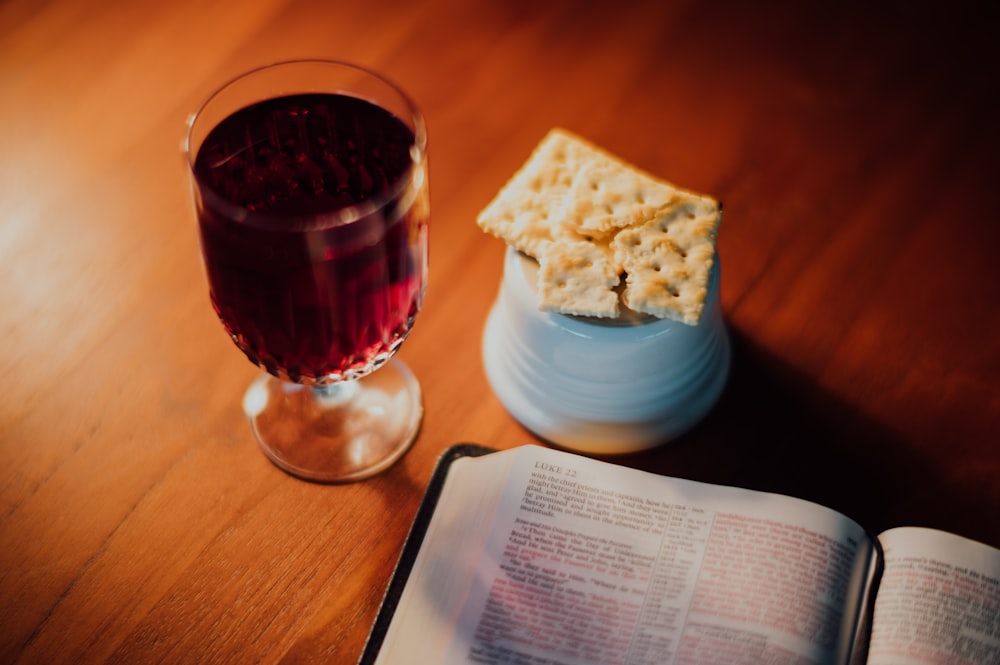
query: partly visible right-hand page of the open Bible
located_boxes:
[868,528,1000,665]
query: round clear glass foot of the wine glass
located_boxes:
[243,358,424,483]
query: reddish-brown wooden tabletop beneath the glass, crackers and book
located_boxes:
[0,0,1000,663]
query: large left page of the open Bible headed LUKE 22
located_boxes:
[378,446,872,665]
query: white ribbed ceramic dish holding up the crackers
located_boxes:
[483,249,730,454]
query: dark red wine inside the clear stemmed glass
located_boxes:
[195,94,427,383]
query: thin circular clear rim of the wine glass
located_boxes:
[182,58,427,231]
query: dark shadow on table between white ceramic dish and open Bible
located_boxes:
[612,330,996,544]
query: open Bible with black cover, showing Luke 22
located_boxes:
[361,445,1000,665]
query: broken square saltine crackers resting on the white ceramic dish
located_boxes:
[476,128,722,325]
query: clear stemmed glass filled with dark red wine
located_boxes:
[184,60,429,482]
